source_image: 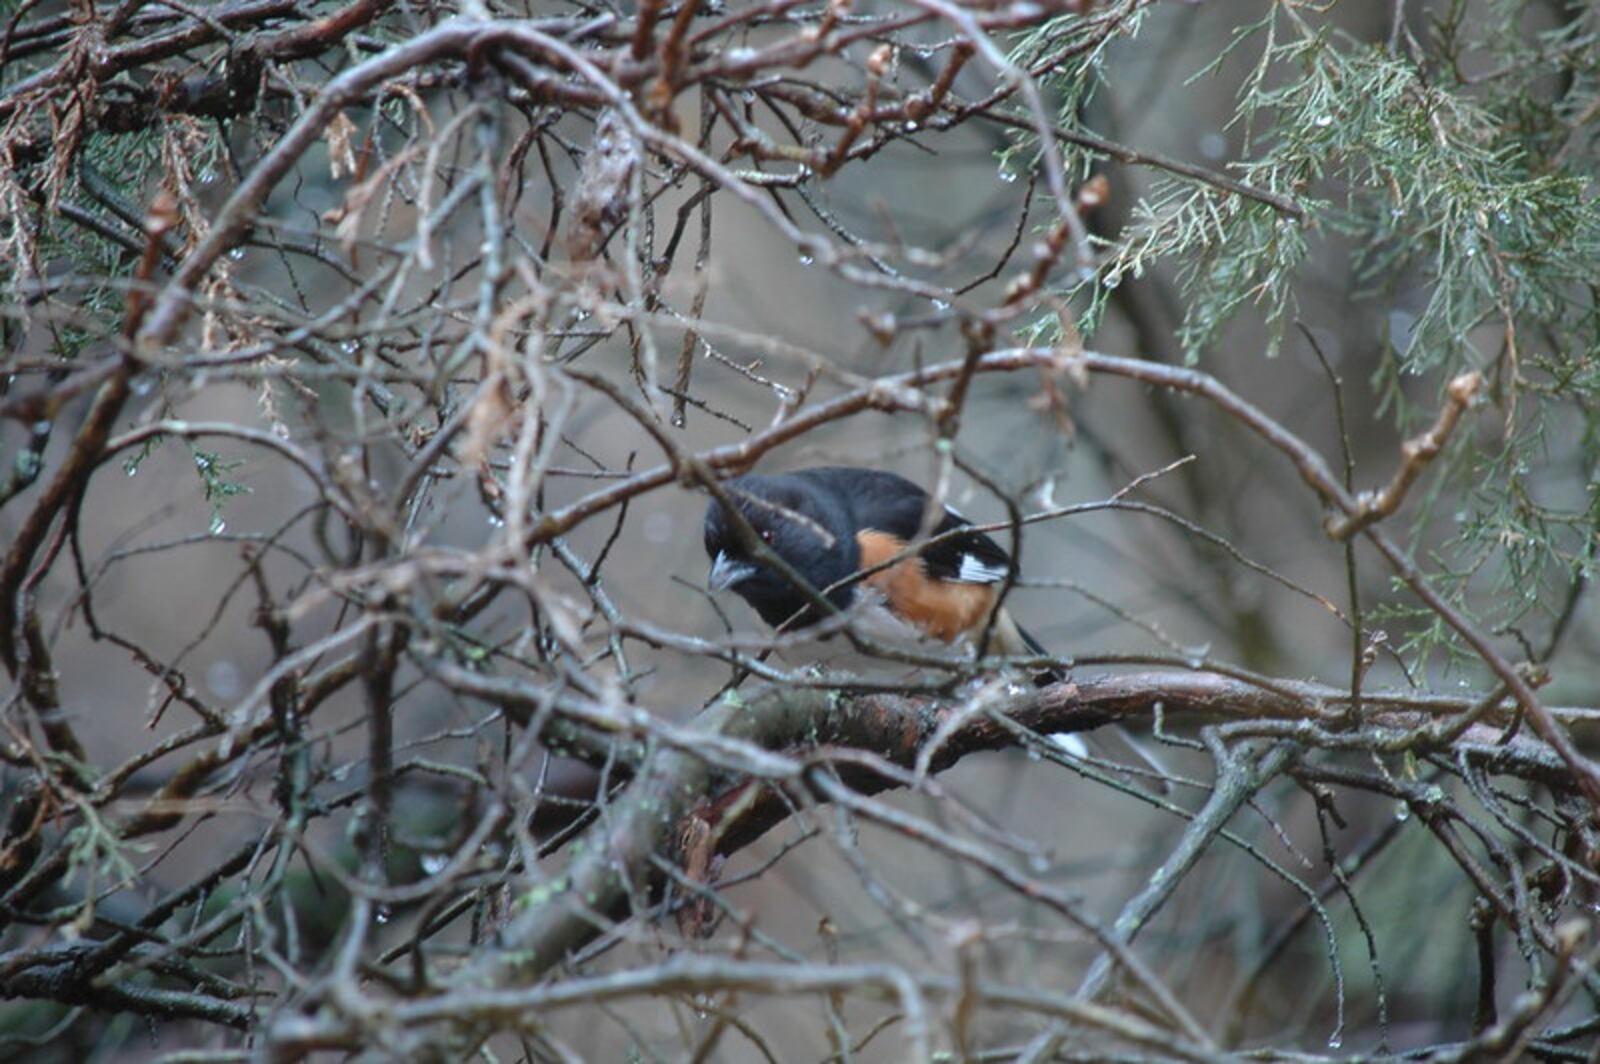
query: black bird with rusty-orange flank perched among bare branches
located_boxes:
[706,466,1061,685]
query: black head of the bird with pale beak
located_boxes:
[706,474,861,627]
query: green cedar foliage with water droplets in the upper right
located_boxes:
[1003,0,1600,672]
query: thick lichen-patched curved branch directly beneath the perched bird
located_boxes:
[422,670,1584,986]
